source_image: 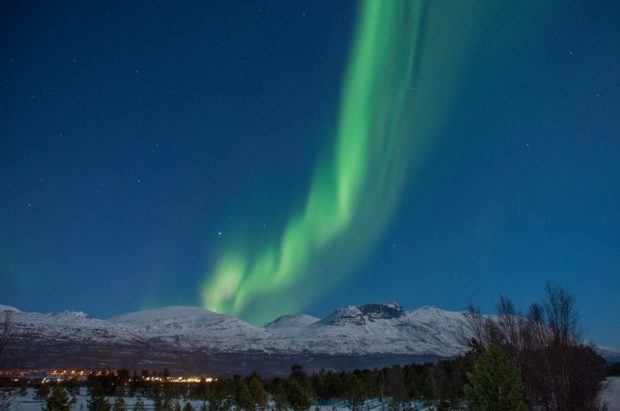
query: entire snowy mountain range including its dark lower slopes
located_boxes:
[0,302,618,374]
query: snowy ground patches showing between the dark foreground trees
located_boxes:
[6,377,620,411]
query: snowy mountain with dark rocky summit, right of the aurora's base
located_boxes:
[262,303,466,356]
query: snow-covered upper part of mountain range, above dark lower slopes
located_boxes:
[0,303,466,356]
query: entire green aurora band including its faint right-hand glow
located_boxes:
[202,0,544,323]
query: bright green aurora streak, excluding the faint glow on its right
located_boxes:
[203,1,424,322]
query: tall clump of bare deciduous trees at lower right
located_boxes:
[468,284,604,410]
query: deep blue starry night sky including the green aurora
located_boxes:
[0,0,620,346]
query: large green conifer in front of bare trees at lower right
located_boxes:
[464,345,527,411]
